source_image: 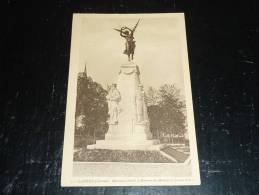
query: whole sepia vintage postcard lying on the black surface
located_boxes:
[61,13,200,186]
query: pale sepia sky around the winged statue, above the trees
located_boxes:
[76,15,187,91]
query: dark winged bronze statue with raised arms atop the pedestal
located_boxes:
[114,20,139,61]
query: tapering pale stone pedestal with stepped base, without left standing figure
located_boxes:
[88,62,159,150]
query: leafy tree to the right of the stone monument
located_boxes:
[146,84,186,141]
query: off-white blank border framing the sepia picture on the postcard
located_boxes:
[61,13,200,186]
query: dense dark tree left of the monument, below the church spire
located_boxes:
[75,75,108,142]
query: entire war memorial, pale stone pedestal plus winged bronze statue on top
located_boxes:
[88,20,159,150]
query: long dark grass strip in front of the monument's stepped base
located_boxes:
[74,149,173,163]
